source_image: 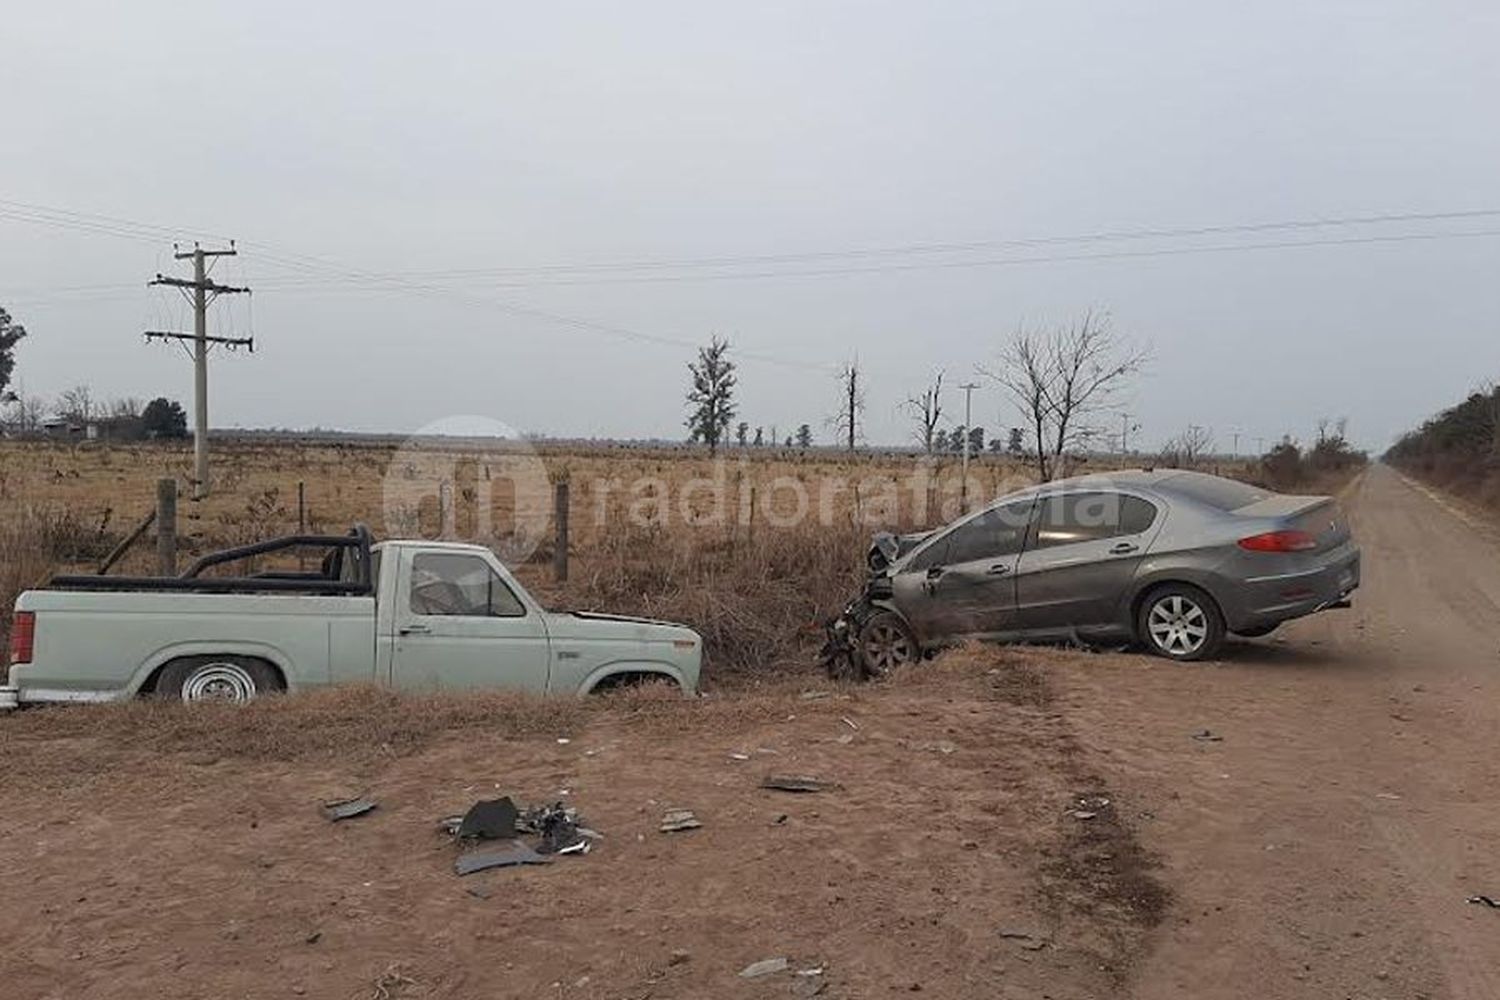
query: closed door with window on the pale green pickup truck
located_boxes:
[390,549,551,691]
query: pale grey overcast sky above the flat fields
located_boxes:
[0,0,1500,450]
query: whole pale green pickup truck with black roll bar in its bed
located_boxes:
[0,526,702,708]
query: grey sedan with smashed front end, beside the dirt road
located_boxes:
[824,469,1359,676]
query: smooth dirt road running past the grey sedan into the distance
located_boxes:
[1053,466,1500,1000]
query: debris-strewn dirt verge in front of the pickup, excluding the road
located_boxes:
[0,652,1166,1000]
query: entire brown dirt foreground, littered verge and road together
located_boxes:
[0,468,1500,1000]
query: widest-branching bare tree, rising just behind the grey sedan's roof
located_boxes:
[980,310,1149,481]
